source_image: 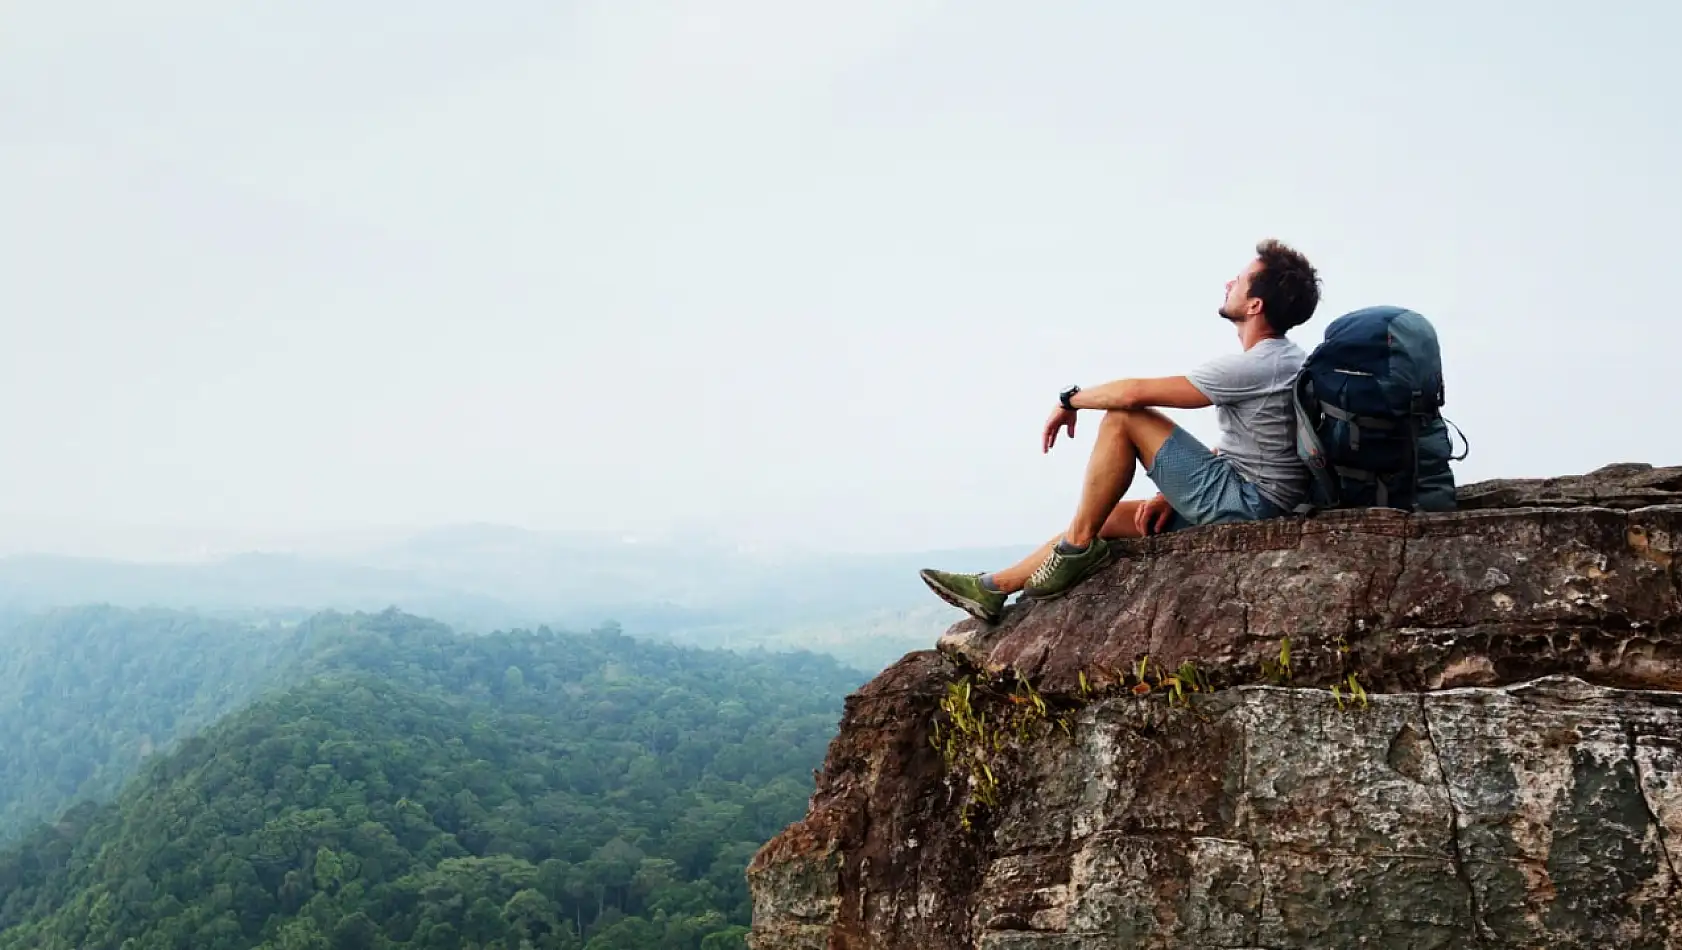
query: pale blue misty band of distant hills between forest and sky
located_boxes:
[0,525,1026,668]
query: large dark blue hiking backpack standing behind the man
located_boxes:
[1293,306,1465,511]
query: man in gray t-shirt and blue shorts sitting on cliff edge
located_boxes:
[922,240,1320,622]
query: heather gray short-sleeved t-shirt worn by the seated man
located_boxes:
[1187,338,1309,509]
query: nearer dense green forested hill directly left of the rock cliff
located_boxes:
[0,612,863,950]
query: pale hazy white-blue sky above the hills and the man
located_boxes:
[0,0,1682,548]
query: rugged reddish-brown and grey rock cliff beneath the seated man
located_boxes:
[748,466,1682,950]
